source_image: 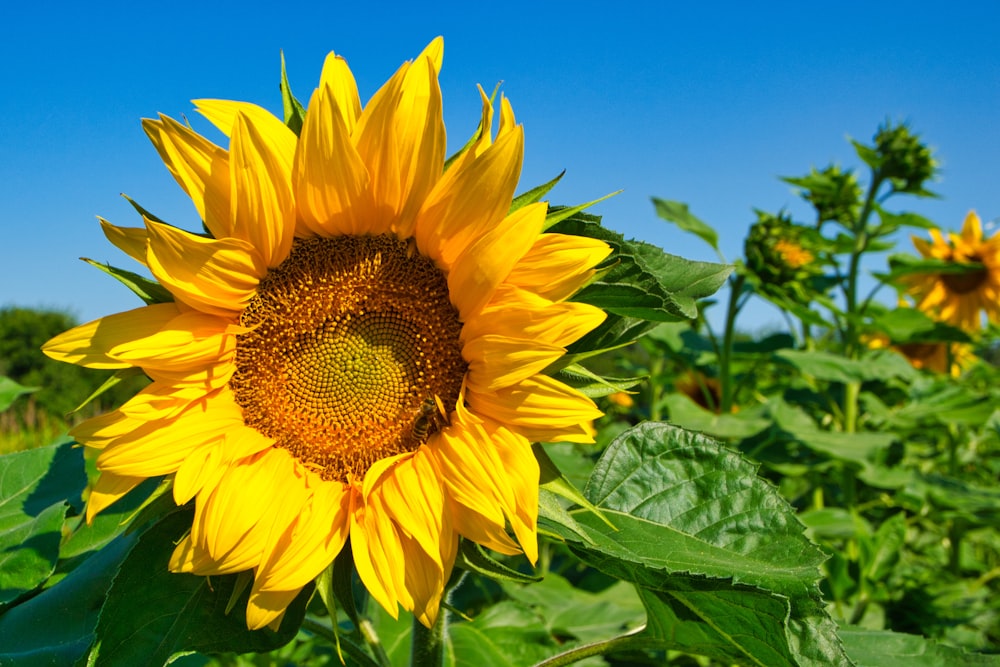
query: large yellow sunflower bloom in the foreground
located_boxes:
[45,38,610,629]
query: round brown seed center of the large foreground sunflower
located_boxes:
[230,236,467,481]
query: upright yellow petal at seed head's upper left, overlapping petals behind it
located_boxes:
[229,111,295,267]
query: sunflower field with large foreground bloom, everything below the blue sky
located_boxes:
[0,39,1000,667]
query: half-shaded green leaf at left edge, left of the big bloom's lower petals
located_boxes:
[0,443,87,604]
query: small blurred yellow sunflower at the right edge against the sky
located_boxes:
[903,211,1000,331]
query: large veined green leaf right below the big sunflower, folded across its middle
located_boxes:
[566,423,849,665]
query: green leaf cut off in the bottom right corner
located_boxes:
[840,626,1000,667]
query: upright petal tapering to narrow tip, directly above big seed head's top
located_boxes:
[292,86,378,236]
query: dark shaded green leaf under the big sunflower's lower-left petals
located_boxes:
[90,510,312,667]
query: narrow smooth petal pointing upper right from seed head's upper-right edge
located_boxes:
[448,202,548,321]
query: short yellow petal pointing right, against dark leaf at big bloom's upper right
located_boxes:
[507,234,611,301]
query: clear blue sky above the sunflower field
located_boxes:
[0,1,1000,327]
